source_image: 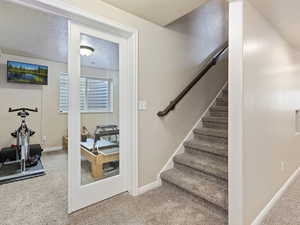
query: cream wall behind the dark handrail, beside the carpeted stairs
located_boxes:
[59,0,227,186]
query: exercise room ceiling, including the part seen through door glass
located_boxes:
[0,1,119,70]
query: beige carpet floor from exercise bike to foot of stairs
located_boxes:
[0,152,226,225]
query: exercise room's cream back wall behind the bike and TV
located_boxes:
[0,55,119,148]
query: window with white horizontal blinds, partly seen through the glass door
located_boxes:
[59,73,113,112]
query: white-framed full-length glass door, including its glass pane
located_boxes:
[65,21,130,213]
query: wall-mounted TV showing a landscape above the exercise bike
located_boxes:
[7,61,48,85]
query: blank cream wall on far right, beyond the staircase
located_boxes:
[229,1,300,225]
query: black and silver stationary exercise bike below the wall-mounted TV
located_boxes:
[0,108,45,184]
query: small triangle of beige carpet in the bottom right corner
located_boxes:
[262,176,300,225]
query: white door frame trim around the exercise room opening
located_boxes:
[9,0,138,209]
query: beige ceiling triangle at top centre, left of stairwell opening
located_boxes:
[102,0,208,26]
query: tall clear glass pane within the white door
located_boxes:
[79,34,120,185]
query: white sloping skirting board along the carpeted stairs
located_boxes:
[157,82,228,181]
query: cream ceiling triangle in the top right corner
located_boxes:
[250,0,300,50]
